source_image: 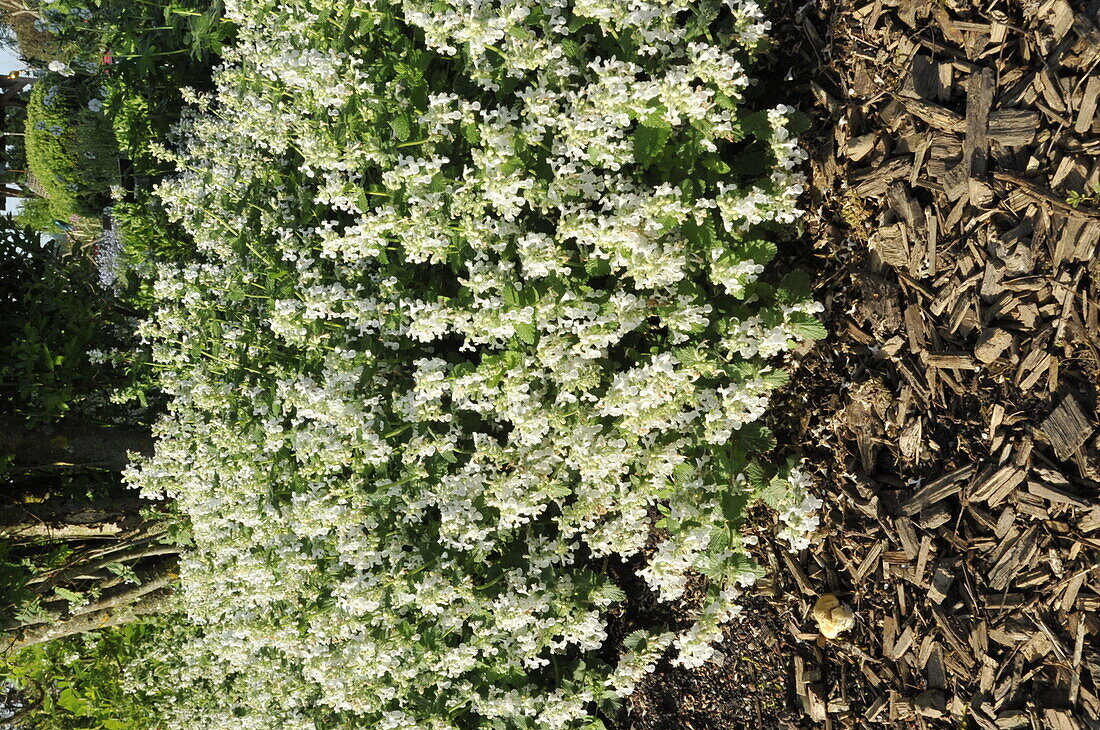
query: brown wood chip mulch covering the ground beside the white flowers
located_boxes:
[623,0,1100,730]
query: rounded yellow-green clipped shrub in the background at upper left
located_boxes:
[26,74,119,221]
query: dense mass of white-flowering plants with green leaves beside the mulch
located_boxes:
[129,0,806,730]
